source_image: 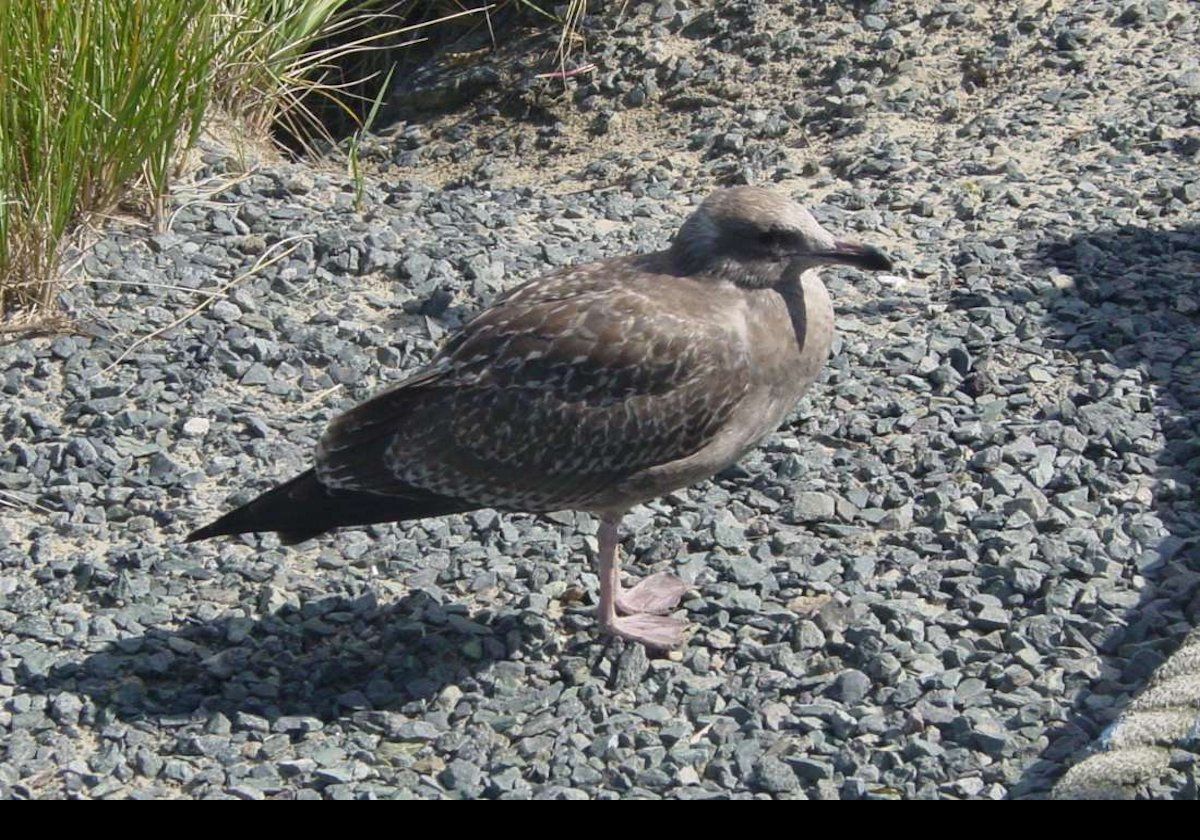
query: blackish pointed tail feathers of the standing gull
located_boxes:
[187,469,478,545]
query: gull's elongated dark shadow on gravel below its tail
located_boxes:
[23,593,540,726]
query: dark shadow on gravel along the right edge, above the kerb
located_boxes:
[1013,226,1200,797]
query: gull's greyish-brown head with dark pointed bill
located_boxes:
[671,187,892,288]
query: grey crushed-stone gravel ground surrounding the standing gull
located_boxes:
[0,0,1200,799]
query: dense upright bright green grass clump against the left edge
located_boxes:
[0,0,220,312]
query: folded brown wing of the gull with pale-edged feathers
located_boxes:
[317,273,749,510]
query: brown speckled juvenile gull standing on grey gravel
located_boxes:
[187,187,890,648]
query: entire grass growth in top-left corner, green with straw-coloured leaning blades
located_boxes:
[0,0,357,314]
